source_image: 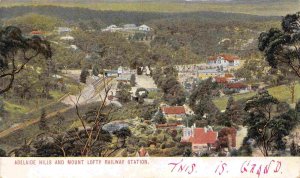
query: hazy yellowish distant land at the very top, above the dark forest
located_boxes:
[0,0,300,16]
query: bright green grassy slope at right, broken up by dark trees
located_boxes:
[213,84,300,110]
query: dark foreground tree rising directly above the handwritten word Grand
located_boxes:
[244,90,296,156]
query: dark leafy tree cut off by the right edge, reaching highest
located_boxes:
[258,12,300,78]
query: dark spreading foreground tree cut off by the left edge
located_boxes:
[0,26,52,95]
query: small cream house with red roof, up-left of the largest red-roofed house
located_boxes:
[161,106,186,121]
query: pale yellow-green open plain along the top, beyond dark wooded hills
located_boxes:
[0,1,300,16]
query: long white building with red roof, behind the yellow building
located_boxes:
[208,54,240,67]
